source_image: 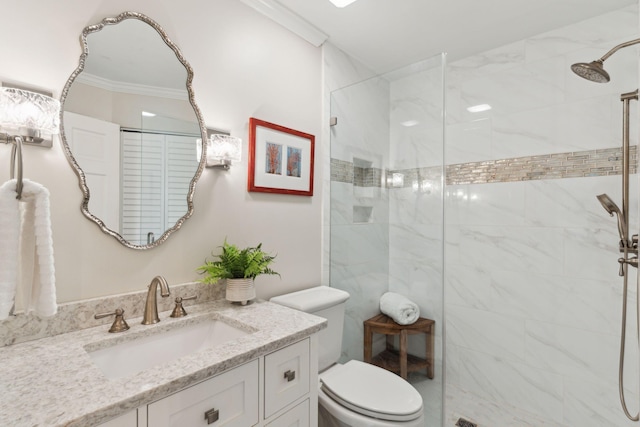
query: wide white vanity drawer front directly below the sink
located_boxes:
[148,360,258,427]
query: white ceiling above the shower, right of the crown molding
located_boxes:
[275,0,638,73]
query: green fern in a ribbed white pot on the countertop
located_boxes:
[198,239,279,305]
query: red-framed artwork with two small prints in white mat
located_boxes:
[248,117,315,196]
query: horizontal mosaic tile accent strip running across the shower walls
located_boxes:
[331,145,638,188]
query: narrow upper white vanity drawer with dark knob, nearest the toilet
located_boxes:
[264,338,310,418]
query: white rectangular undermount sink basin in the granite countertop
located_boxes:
[86,319,250,379]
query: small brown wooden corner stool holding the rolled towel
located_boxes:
[364,314,436,380]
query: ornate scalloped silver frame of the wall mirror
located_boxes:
[60,12,207,249]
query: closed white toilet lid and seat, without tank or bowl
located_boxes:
[320,360,422,421]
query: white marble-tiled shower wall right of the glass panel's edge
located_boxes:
[445,5,638,427]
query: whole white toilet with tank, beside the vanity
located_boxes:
[271,286,425,427]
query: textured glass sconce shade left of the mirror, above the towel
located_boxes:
[0,87,60,137]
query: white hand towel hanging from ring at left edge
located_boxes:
[0,179,58,319]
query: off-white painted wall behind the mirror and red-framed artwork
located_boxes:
[0,0,323,302]
